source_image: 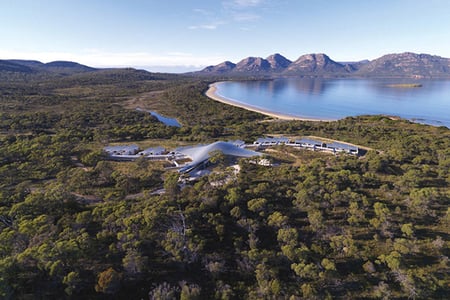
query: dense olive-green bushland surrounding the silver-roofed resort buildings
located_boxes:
[0,69,450,299]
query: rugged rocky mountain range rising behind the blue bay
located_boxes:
[191,52,450,78]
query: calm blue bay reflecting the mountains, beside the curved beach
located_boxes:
[216,78,450,128]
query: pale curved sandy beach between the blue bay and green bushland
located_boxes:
[205,82,333,122]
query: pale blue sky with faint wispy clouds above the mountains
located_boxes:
[0,0,450,72]
